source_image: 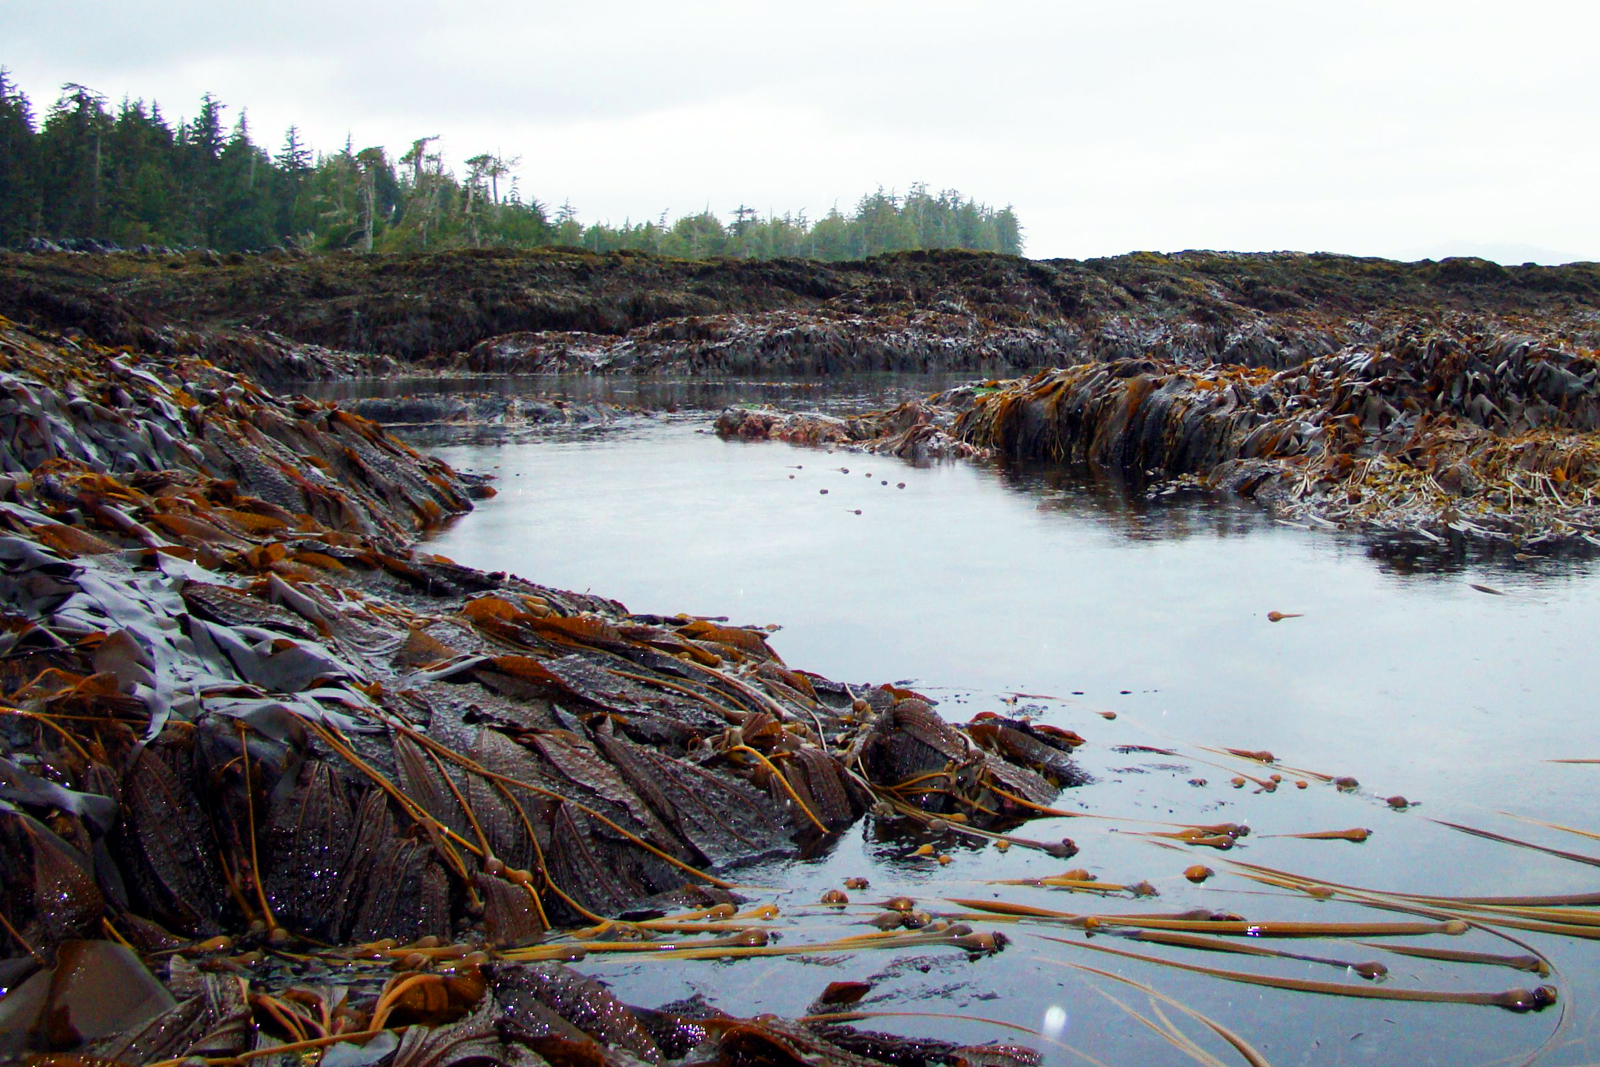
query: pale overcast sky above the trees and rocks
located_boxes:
[0,0,1600,262]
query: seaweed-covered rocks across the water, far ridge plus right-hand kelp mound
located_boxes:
[12,251,1600,544]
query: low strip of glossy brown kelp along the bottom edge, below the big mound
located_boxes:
[0,941,1040,1067]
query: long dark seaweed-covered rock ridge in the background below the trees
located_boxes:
[0,251,1600,382]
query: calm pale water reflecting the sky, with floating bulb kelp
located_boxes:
[432,391,1600,1064]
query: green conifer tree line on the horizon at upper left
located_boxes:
[0,69,1022,261]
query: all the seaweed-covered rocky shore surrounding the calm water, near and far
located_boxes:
[0,253,1600,1067]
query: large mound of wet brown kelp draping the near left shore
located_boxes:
[0,323,1077,1064]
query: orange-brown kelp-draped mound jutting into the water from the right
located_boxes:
[717,315,1600,544]
